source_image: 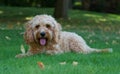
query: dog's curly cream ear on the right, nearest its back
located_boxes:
[53,22,62,44]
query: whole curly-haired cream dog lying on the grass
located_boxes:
[16,15,112,57]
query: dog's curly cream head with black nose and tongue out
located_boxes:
[24,15,61,46]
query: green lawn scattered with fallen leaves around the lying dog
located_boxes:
[0,7,120,74]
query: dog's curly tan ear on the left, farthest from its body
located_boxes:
[24,22,34,44]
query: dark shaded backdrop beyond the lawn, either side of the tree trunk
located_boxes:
[0,0,120,14]
